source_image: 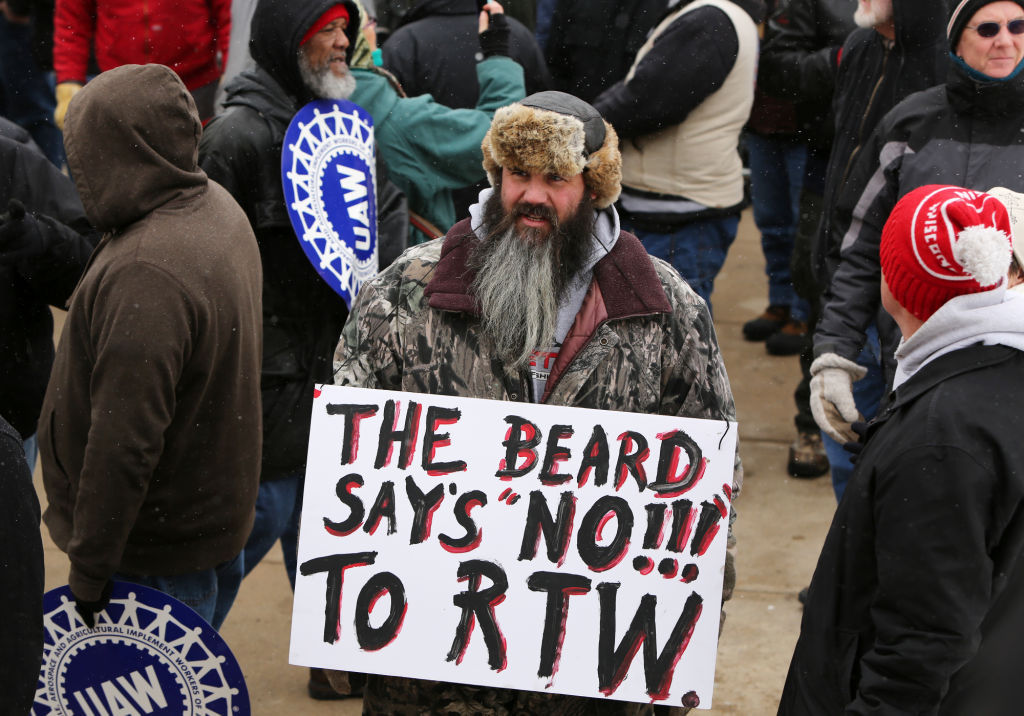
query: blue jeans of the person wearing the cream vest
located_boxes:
[623,216,739,310]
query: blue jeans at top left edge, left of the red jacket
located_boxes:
[0,15,65,167]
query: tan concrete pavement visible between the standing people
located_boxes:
[36,210,835,716]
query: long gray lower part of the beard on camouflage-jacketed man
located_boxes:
[473,227,558,373]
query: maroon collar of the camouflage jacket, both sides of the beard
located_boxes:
[424,218,672,320]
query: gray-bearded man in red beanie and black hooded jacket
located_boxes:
[200,0,368,699]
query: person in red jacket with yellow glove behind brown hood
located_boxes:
[53,0,231,124]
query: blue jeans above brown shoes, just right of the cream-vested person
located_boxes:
[745,133,810,321]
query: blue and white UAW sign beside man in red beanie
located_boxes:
[281,99,378,306]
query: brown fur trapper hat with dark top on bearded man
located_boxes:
[481,92,623,209]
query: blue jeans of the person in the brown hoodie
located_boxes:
[114,553,242,631]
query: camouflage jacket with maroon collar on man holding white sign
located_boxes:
[335,219,742,716]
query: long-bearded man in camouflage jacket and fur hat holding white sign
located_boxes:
[335,92,741,714]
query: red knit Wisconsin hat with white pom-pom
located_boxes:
[879,184,1013,321]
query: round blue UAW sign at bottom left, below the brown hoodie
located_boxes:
[35,582,250,716]
